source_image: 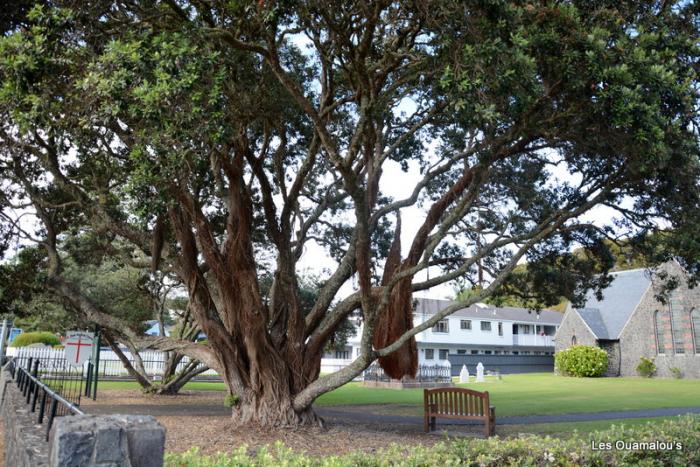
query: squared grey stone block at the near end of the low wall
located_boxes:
[49,415,165,467]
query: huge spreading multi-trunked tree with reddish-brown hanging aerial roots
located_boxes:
[0,0,699,426]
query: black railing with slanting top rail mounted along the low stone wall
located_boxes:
[8,359,85,441]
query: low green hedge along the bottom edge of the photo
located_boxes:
[165,416,700,467]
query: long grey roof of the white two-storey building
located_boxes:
[415,298,564,326]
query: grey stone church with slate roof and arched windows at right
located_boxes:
[555,262,700,378]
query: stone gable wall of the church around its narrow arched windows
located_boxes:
[620,262,700,378]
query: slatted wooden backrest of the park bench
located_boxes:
[423,388,489,417]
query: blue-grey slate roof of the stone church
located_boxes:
[576,269,651,340]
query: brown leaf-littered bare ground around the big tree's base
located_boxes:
[81,391,460,456]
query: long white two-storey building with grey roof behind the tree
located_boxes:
[334,298,563,364]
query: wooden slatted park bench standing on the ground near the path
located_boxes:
[423,388,496,437]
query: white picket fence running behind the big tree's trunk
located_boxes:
[7,347,352,377]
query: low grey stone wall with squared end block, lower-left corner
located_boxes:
[0,370,165,467]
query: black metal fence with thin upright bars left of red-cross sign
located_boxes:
[14,348,88,407]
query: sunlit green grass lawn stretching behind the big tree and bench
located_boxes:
[98,373,700,418]
